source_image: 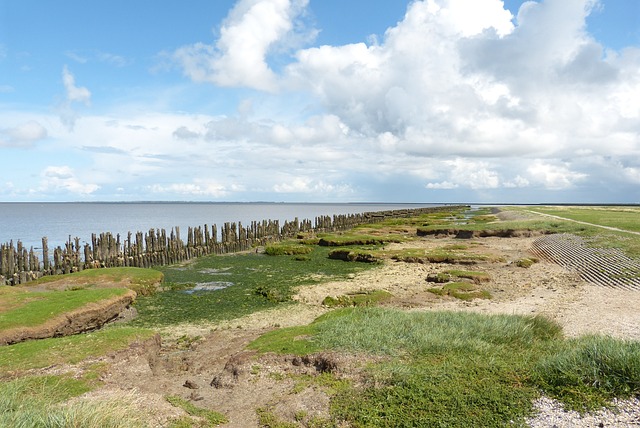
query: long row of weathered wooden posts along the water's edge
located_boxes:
[0,206,457,285]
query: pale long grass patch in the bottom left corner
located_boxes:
[0,376,144,428]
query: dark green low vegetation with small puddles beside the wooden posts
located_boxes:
[133,246,373,327]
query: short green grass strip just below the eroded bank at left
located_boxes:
[0,326,155,375]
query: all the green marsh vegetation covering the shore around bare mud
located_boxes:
[0,208,640,427]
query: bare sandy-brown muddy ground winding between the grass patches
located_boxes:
[36,237,640,428]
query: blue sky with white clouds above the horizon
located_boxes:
[0,0,640,203]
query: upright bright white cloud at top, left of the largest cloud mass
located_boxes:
[173,0,308,91]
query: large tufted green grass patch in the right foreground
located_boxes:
[251,308,640,427]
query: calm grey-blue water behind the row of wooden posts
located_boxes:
[0,203,434,248]
